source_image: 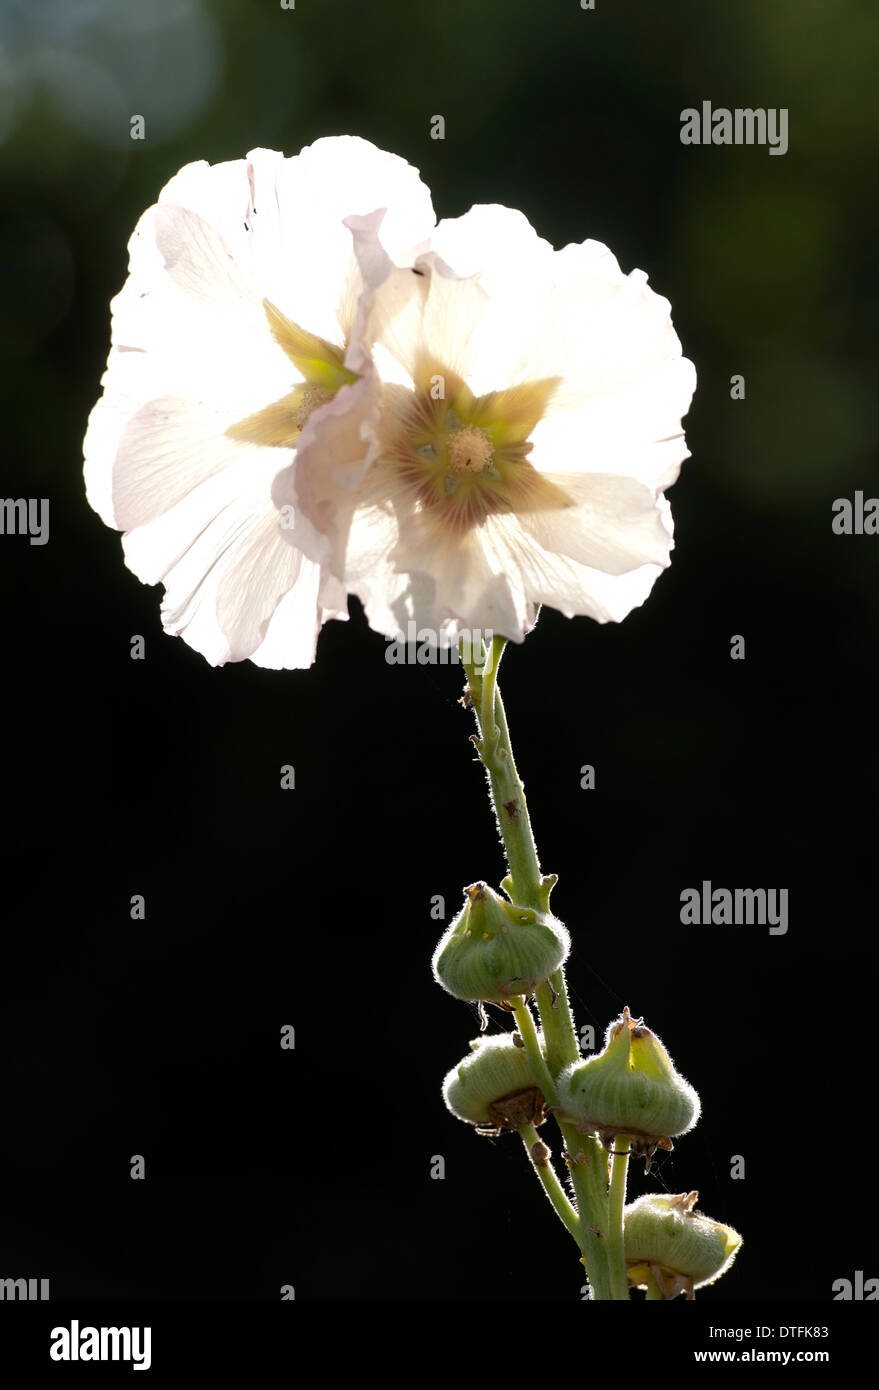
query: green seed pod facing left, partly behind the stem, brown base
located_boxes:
[442,1033,545,1134]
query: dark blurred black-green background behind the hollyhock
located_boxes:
[0,0,879,1301]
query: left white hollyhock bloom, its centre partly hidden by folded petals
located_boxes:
[83,136,434,667]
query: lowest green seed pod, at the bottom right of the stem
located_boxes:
[623,1193,741,1298]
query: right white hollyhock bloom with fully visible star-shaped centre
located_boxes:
[285,206,695,642]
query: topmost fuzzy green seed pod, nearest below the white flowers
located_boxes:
[433,883,570,1005]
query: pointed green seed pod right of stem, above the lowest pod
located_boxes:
[558,1009,701,1166]
